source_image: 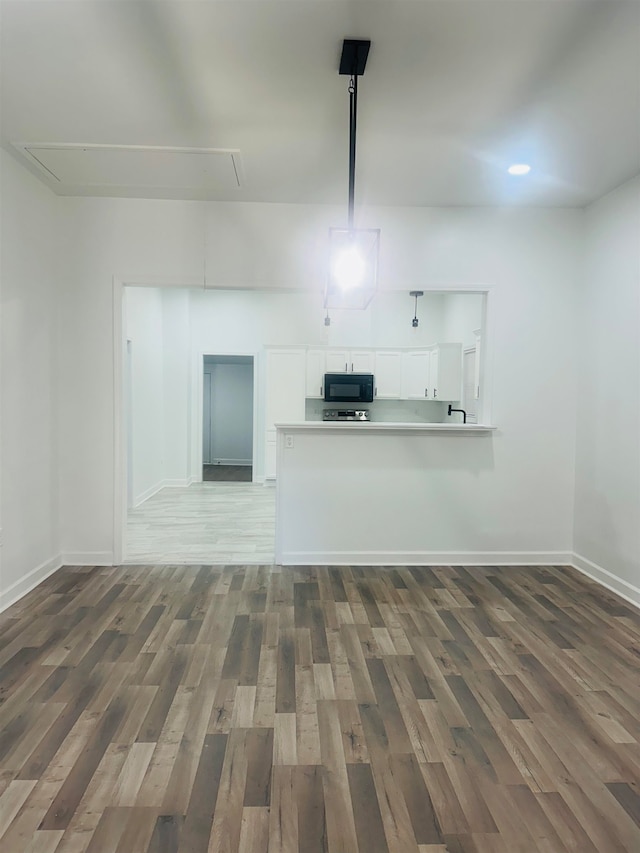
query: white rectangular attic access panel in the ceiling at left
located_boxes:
[16,143,241,191]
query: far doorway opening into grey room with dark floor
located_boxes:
[202,355,254,483]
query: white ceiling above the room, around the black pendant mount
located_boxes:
[0,0,640,206]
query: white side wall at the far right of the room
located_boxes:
[575,178,640,603]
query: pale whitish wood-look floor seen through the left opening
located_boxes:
[125,482,276,564]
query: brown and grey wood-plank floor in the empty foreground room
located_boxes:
[0,566,640,853]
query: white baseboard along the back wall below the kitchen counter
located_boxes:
[276,551,573,566]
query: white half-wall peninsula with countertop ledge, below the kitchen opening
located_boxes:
[276,421,495,565]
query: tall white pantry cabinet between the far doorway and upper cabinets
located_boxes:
[264,349,306,478]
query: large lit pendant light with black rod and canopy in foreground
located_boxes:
[324,39,380,309]
